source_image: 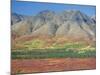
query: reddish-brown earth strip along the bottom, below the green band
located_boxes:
[11,58,96,75]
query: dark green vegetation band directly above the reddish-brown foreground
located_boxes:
[12,49,96,59]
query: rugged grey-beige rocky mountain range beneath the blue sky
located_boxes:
[11,10,96,40]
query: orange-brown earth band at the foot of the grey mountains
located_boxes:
[11,35,95,50]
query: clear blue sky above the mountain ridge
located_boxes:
[11,0,96,16]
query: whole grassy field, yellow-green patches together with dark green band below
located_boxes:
[12,40,96,59]
